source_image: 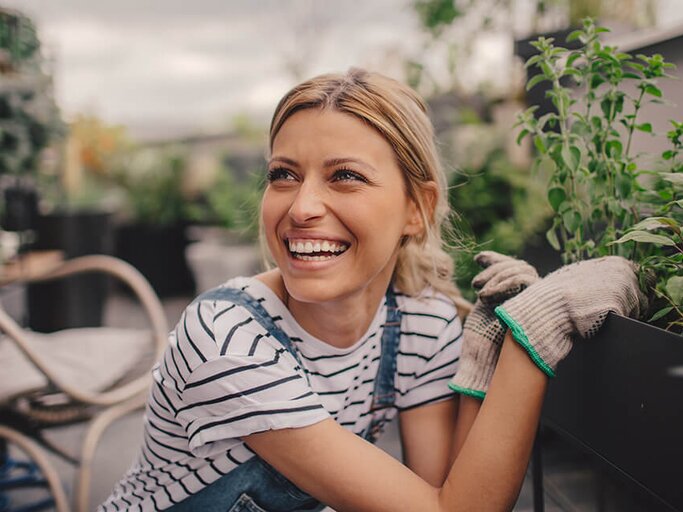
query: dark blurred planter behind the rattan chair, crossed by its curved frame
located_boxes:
[28,211,113,332]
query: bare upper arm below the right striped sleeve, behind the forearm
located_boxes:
[399,395,459,487]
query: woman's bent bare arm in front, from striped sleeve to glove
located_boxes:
[245,335,547,512]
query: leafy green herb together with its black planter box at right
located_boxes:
[519,19,683,510]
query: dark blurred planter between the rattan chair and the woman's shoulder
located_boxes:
[116,224,195,297]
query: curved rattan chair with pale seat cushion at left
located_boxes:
[0,255,168,512]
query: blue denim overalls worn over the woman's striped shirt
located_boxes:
[169,286,401,512]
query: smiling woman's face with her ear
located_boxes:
[261,109,422,303]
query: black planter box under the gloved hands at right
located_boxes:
[542,314,683,511]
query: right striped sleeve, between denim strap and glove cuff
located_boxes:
[396,315,462,410]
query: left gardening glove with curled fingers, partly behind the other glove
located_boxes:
[448,251,538,400]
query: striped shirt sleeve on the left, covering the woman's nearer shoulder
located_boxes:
[176,298,330,457]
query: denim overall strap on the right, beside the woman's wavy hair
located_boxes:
[372,285,401,410]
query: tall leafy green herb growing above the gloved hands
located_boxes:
[518,19,683,332]
